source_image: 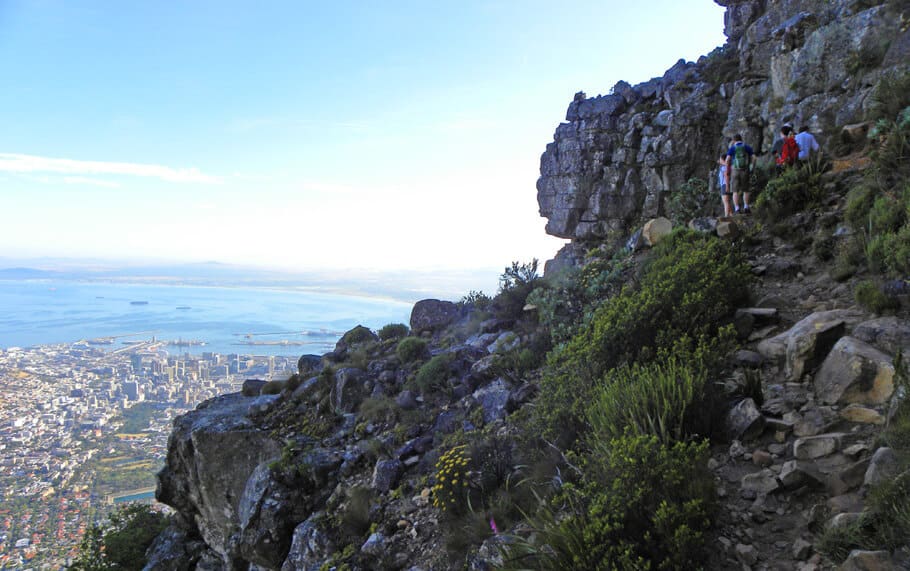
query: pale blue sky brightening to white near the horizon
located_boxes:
[0,0,725,278]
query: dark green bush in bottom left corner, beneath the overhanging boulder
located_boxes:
[70,504,169,571]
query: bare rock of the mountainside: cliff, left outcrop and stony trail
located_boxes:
[147,0,910,571]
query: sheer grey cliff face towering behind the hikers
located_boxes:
[537,0,910,254]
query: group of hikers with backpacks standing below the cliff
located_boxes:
[717,123,820,217]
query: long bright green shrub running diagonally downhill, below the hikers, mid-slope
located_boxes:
[536,230,751,440]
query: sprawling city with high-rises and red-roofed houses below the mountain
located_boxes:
[0,339,296,569]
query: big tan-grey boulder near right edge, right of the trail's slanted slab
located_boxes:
[815,337,894,404]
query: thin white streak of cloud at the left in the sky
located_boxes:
[0,153,221,184]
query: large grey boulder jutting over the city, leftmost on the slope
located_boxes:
[155,394,282,564]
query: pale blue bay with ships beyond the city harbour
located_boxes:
[0,279,412,356]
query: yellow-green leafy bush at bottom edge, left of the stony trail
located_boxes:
[504,435,715,571]
